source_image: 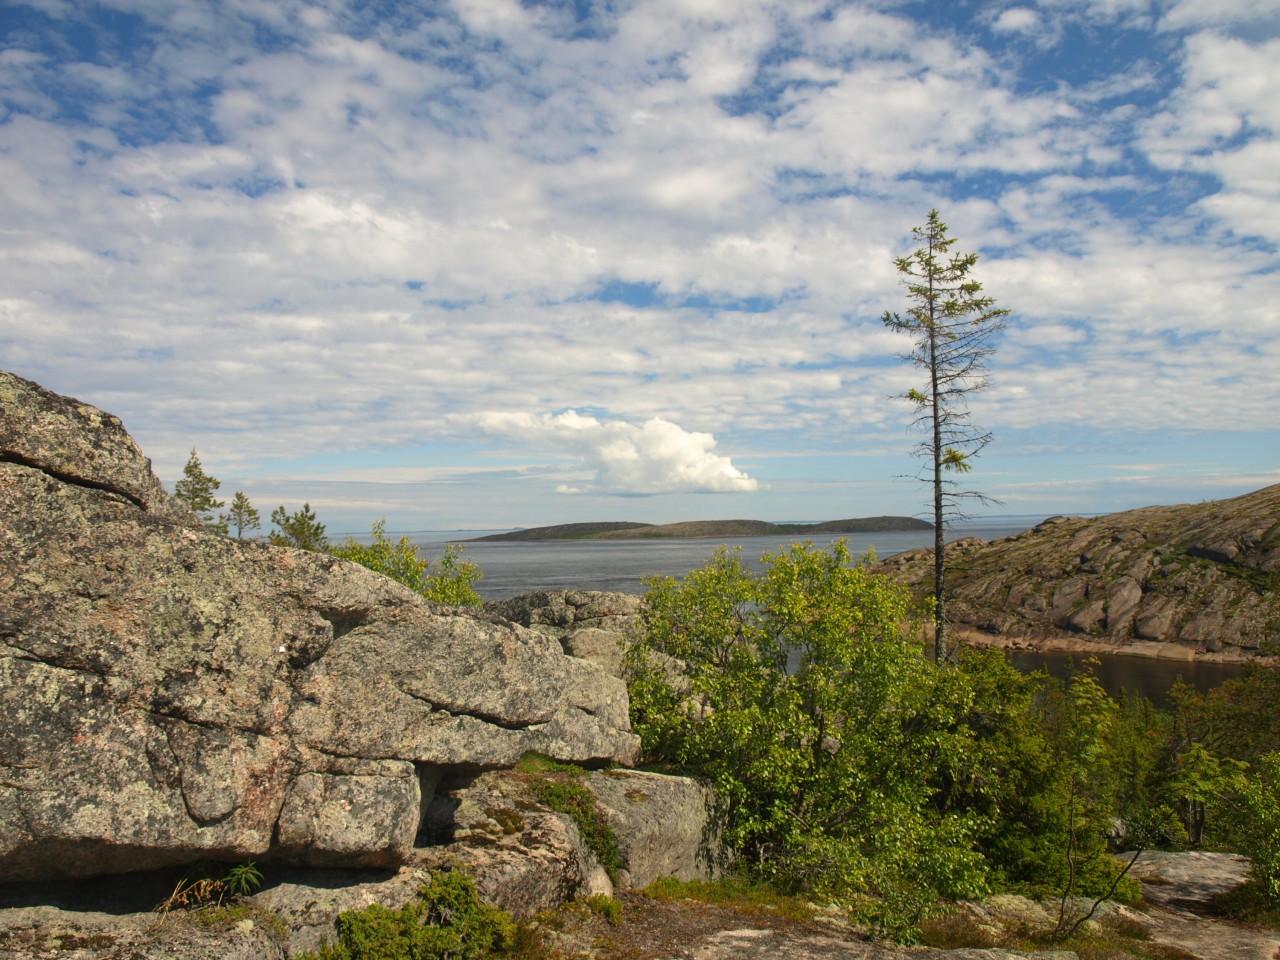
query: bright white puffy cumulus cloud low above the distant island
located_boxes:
[477,410,760,495]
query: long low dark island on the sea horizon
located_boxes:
[467,517,933,543]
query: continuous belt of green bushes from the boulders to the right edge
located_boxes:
[627,544,1280,941]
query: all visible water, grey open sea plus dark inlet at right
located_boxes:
[381,516,1242,705]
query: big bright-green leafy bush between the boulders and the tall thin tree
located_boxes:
[627,541,988,931]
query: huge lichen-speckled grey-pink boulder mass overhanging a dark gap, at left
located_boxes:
[0,372,637,881]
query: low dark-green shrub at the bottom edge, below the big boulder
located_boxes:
[300,872,517,960]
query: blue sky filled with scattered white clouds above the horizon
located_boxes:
[0,0,1280,532]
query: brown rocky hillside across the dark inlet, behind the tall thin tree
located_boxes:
[879,485,1280,657]
